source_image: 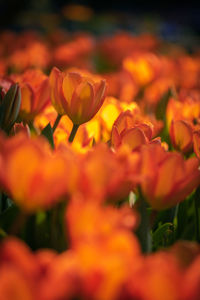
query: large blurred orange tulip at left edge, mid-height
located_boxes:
[0,133,78,212]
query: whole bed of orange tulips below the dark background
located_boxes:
[0,32,200,300]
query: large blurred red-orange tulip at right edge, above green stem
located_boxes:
[141,144,200,210]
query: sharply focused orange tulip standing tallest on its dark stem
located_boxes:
[49,67,106,125]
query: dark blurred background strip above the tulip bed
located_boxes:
[0,0,200,40]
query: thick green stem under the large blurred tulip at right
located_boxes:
[136,193,152,253]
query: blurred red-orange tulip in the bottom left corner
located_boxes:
[0,237,40,300]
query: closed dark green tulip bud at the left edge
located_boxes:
[0,83,21,132]
